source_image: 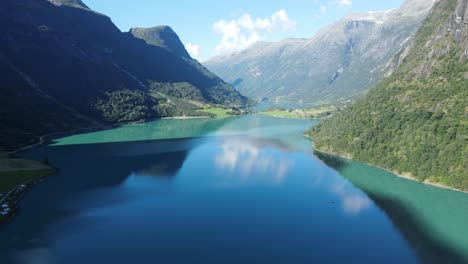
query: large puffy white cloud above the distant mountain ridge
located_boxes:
[213,9,296,55]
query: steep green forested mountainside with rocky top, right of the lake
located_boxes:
[309,0,468,191]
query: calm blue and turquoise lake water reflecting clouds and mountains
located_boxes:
[0,115,468,264]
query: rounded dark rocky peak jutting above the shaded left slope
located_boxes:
[130,25,190,58]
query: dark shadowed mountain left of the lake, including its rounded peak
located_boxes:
[0,0,248,149]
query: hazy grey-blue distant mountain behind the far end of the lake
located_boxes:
[204,0,435,104]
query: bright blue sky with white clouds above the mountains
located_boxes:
[83,0,404,61]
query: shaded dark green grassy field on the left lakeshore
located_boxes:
[0,158,55,193]
